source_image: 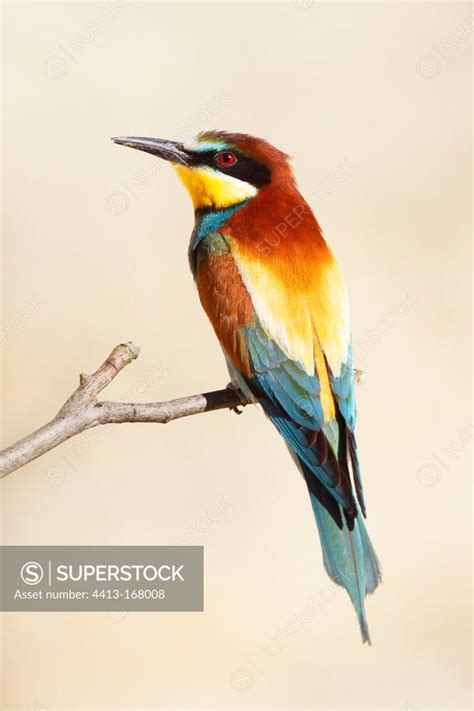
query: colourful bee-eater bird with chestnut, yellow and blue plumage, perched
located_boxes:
[112,130,381,644]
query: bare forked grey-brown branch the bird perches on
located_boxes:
[0,342,363,478]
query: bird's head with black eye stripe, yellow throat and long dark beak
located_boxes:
[112,131,293,210]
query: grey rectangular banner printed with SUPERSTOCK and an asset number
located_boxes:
[0,546,204,612]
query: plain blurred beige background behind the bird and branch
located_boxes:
[0,0,472,709]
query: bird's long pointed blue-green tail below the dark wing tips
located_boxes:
[300,462,382,644]
